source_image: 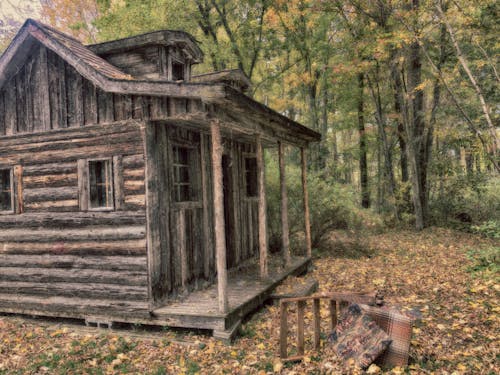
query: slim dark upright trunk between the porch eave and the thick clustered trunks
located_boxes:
[358,73,370,208]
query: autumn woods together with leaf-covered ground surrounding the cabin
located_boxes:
[0,0,500,374]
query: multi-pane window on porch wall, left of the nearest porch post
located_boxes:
[173,146,198,202]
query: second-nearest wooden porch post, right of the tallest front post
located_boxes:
[256,134,268,278]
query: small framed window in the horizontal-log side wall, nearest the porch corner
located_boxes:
[88,160,114,208]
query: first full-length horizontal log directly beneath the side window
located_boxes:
[0,211,146,229]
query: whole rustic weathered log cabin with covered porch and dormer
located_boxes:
[0,19,320,339]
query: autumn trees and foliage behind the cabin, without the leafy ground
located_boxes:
[0,0,500,232]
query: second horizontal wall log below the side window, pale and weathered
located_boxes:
[0,225,146,242]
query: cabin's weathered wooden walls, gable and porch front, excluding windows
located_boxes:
[0,40,258,316]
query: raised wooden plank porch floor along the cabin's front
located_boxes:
[151,256,311,341]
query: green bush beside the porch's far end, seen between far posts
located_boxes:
[266,156,373,252]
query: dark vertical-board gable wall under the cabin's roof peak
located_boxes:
[0,46,201,136]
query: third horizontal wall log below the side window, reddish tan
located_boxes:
[0,238,146,256]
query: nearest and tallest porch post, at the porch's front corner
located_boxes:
[210,120,228,313]
